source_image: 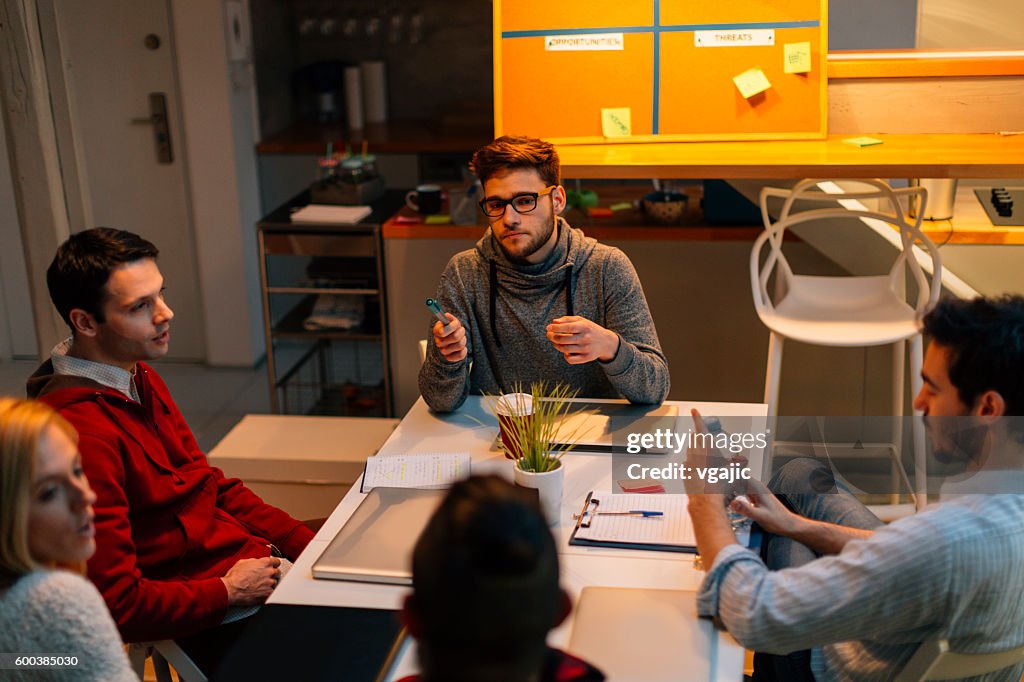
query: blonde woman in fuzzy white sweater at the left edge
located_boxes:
[0,398,138,682]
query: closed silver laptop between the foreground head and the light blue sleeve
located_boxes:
[568,587,743,682]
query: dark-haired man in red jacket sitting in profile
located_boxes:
[28,227,313,672]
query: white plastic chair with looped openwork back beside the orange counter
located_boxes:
[751,179,942,509]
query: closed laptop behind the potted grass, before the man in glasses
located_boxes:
[556,401,679,455]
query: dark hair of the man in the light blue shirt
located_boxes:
[924,295,1024,413]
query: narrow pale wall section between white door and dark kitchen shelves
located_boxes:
[171,0,264,366]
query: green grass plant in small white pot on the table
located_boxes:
[495,382,581,525]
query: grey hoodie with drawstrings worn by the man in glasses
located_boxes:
[420,218,669,412]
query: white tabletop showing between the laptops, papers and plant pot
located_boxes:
[267,396,767,681]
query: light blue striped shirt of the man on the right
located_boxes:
[697,489,1024,682]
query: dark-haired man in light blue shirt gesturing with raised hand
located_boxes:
[689,296,1024,682]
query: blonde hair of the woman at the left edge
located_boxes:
[0,397,78,586]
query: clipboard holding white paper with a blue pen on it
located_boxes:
[569,492,697,554]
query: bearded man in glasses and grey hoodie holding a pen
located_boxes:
[420,137,669,412]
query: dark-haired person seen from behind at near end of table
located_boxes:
[401,476,604,682]
